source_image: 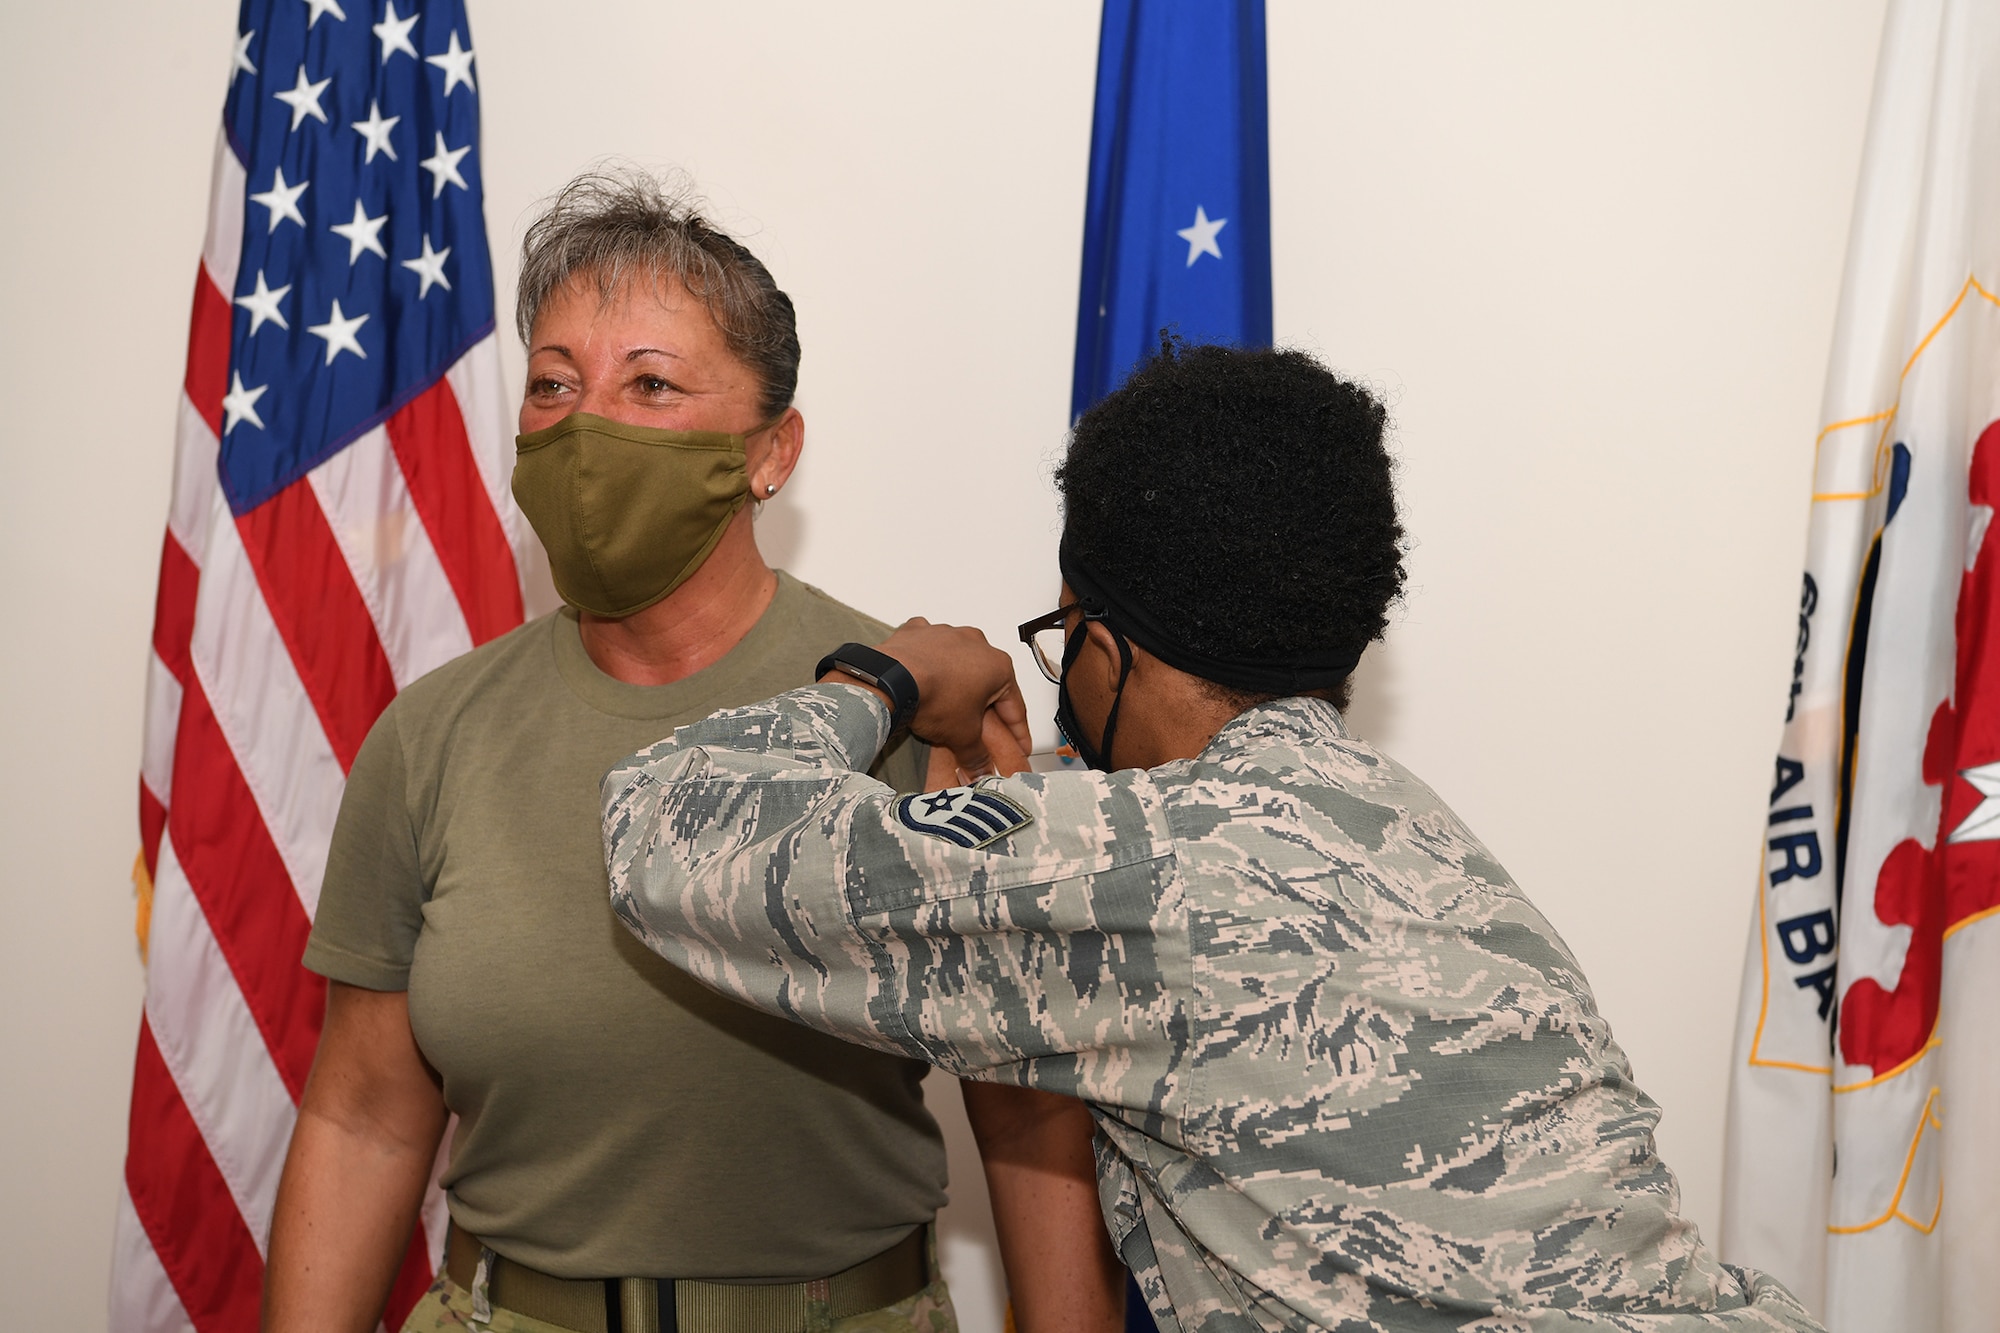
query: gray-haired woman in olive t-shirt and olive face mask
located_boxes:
[264,172,1118,1333]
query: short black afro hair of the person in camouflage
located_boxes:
[1056,334,1404,703]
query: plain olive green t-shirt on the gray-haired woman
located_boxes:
[306,574,944,1281]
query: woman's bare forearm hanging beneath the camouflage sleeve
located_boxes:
[962,1083,1124,1333]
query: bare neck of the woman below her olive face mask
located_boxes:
[576,504,778,685]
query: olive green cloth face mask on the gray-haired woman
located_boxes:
[514,412,750,618]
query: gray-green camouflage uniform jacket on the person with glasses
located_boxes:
[604,685,1818,1333]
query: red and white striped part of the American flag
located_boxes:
[110,134,528,1333]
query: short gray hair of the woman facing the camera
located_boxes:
[514,168,798,420]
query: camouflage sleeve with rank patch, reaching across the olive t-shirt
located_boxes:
[604,685,1190,1111]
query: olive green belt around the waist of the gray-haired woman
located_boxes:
[444,1227,930,1333]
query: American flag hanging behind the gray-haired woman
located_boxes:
[110,0,524,1333]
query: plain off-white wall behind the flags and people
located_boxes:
[0,0,1882,1329]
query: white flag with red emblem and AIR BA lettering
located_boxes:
[1722,0,2000,1333]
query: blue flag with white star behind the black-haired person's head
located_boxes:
[1070,0,1270,418]
